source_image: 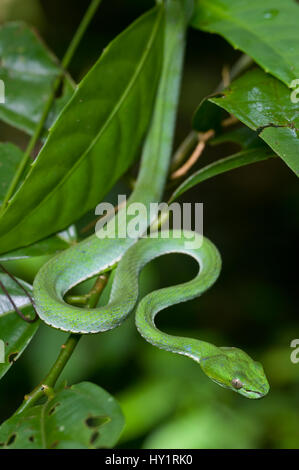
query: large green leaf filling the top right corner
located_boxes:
[191,0,299,86]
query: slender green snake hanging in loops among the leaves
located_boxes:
[33,0,269,398]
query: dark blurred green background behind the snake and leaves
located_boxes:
[0,0,299,448]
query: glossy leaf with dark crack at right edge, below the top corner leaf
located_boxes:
[210,69,299,176]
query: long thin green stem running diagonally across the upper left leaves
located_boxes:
[1,0,102,212]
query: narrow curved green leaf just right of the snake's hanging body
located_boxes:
[170,147,275,202]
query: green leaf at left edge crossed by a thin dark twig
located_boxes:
[0,273,39,378]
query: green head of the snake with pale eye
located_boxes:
[200,347,270,398]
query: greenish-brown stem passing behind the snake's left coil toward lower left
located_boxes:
[14,274,109,415]
